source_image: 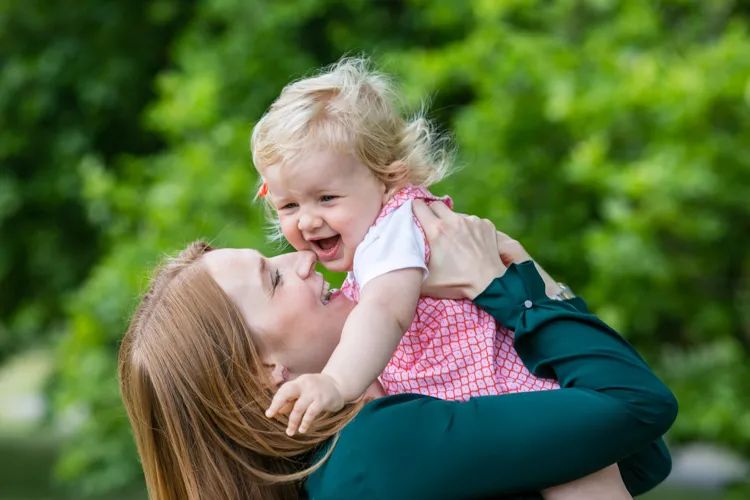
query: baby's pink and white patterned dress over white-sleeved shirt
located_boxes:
[341,186,560,400]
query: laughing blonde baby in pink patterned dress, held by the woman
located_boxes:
[252,55,558,422]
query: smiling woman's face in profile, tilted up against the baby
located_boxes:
[202,248,354,377]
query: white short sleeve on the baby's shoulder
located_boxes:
[352,200,427,290]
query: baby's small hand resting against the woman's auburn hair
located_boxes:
[266,373,344,436]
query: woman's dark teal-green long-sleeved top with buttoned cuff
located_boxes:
[305,262,677,500]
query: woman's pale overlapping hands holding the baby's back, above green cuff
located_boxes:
[413,200,560,299]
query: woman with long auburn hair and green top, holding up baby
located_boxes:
[119,204,676,499]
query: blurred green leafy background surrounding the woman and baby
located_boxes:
[0,0,750,500]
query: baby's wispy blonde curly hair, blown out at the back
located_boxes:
[250,57,452,199]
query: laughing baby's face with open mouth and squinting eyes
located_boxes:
[262,149,386,272]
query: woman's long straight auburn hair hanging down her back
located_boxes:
[118,241,361,500]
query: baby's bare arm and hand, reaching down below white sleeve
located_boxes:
[266,268,424,435]
